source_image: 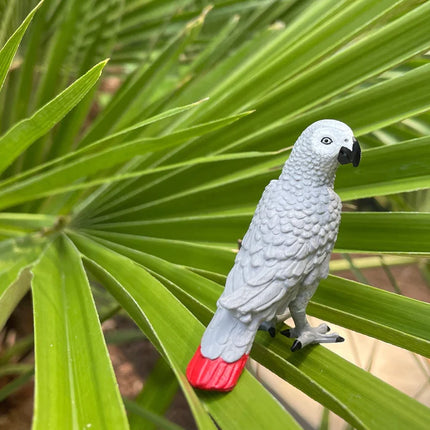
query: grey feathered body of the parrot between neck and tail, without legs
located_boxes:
[218,177,341,322]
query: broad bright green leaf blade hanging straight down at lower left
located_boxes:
[32,237,128,429]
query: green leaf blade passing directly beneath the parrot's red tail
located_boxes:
[72,235,297,429]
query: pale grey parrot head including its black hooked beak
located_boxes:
[305,119,361,167]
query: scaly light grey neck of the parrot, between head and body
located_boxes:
[279,148,338,188]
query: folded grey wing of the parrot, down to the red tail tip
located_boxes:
[202,181,332,361]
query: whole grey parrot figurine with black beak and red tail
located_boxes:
[186,119,361,391]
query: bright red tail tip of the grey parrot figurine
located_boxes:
[187,346,249,391]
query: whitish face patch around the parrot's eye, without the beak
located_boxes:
[311,120,354,159]
